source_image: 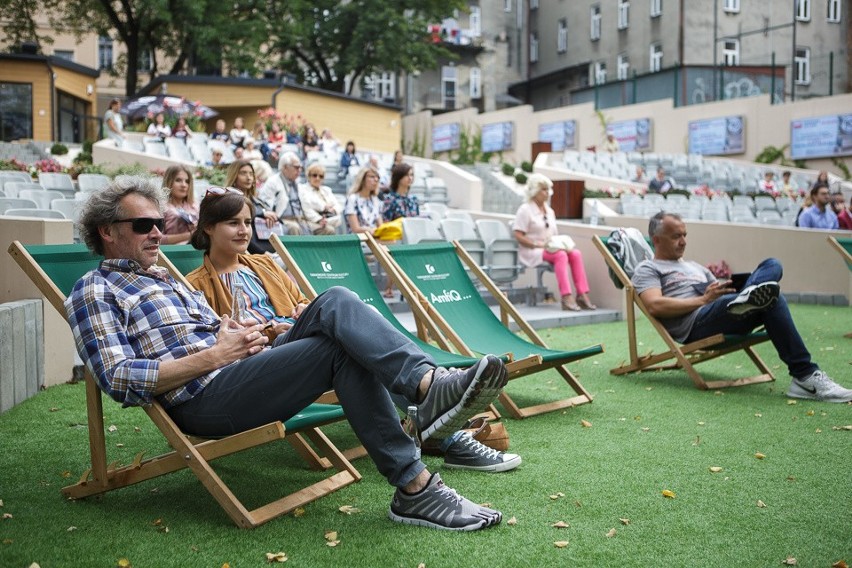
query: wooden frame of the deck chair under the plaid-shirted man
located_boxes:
[9,241,361,528]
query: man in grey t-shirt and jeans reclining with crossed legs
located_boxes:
[632,212,852,402]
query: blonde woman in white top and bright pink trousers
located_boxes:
[514,174,596,311]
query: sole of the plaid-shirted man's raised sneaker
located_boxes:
[420,355,508,440]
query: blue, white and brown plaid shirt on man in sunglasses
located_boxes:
[65,259,225,408]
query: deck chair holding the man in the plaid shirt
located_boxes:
[9,241,361,528]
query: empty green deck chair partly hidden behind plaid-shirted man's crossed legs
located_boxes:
[269,235,486,367]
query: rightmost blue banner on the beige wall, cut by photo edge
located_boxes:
[790,114,852,160]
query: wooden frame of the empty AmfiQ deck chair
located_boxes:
[367,237,603,419]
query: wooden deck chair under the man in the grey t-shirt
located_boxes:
[592,235,775,390]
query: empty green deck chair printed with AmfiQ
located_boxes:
[372,237,603,418]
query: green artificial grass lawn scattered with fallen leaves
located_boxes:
[0,305,852,568]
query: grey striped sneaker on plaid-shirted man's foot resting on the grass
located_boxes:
[388,473,503,531]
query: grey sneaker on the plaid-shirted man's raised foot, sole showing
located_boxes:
[417,355,509,440]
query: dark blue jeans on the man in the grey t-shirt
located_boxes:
[687,258,819,379]
